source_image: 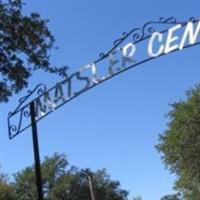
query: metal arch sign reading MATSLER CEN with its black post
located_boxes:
[8,17,200,200]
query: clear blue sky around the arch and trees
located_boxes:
[0,0,200,200]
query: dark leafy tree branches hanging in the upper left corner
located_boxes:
[0,0,67,102]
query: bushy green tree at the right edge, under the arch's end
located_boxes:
[157,85,200,200]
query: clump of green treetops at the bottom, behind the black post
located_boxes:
[13,154,128,200]
